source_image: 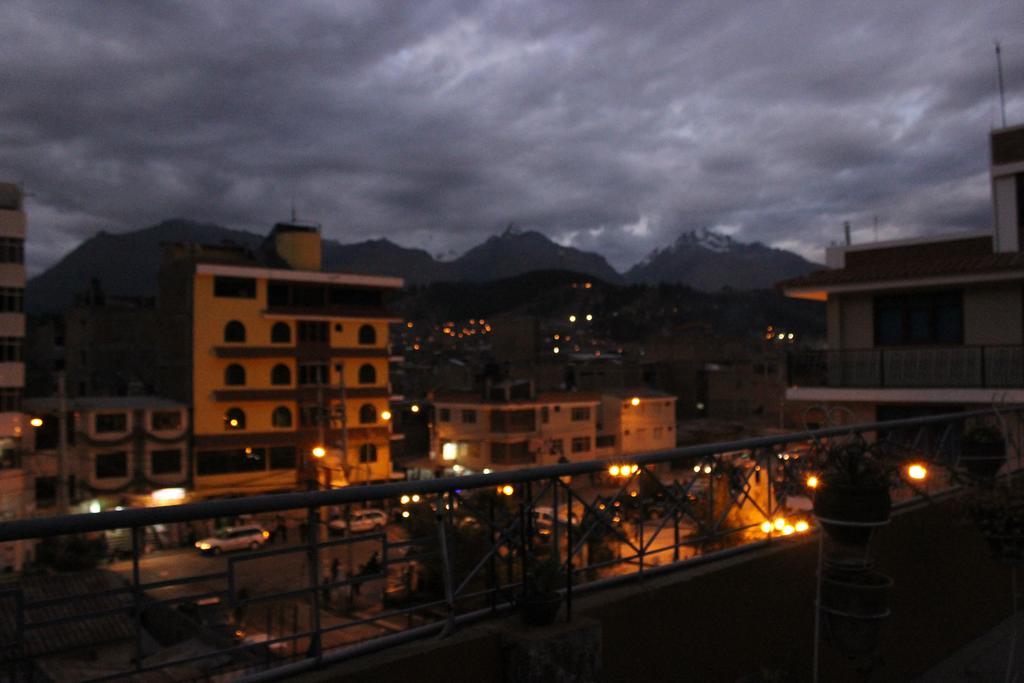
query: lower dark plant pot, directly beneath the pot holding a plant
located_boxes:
[818,568,893,659]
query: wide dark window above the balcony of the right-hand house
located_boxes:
[874,292,964,346]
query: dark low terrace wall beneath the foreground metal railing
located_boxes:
[295,501,1010,682]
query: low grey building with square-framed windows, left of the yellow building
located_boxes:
[25,396,190,513]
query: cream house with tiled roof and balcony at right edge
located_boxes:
[779,126,1024,423]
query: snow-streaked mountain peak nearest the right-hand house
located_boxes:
[626,230,821,292]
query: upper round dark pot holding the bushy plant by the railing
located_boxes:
[814,483,892,546]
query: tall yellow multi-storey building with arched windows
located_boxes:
[161,223,402,497]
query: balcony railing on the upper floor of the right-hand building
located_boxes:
[787,346,1024,389]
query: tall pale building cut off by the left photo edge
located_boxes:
[0,182,28,571]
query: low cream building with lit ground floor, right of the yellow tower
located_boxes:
[431,381,601,473]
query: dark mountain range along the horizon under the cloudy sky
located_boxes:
[26,219,819,313]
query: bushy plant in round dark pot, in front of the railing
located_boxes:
[814,438,892,545]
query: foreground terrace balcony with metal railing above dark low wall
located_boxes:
[0,411,1020,682]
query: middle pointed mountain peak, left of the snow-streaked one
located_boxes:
[452,226,623,283]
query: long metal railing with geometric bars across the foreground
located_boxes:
[0,410,1016,681]
